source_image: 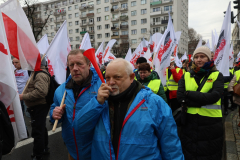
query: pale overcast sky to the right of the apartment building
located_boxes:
[188,0,237,44]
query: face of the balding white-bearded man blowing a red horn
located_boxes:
[105,62,134,96]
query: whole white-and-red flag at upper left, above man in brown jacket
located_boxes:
[0,0,41,71]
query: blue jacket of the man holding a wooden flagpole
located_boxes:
[50,68,102,160]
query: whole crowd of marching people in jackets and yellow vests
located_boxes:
[0,46,240,160]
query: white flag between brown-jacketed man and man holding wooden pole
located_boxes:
[46,20,69,84]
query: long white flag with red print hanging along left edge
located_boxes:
[0,10,27,145]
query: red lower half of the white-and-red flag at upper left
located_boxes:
[2,13,41,71]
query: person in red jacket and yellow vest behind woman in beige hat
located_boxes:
[164,57,183,112]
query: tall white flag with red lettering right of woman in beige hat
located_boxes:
[213,2,231,76]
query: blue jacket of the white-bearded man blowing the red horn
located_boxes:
[73,87,184,160]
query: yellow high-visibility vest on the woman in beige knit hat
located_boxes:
[184,71,222,117]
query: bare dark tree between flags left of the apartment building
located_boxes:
[21,0,50,41]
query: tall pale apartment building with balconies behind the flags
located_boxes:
[36,0,188,55]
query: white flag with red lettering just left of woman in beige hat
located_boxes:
[154,13,177,85]
